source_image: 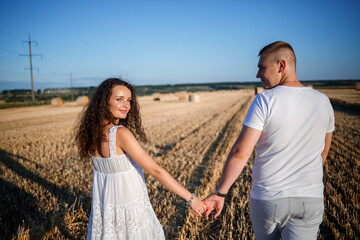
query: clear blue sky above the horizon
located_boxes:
[0,0,360,90]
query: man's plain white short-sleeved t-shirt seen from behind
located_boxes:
[243,86,335,200]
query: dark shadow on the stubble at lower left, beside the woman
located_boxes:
[0,149,91,239]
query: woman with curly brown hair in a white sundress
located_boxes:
[75,78,206,240]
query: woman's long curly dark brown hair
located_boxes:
[75,78,148,162]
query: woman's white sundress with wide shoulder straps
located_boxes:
[86,126,165,240]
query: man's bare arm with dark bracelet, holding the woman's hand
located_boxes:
[203,126,262,219]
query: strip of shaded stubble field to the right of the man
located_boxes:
[320,106,360,239]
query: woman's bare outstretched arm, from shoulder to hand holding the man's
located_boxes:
[116,127,205,215]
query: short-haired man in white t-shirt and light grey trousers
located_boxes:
[203,41,334,239]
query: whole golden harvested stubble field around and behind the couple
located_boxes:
[0,91,360,239]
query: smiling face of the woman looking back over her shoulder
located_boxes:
[108,85,131,119]
